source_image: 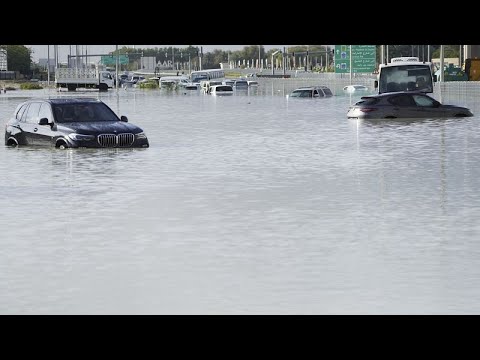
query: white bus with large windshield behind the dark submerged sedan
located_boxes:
[375,57,435,94]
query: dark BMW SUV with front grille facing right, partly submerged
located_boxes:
[5,98,149,149]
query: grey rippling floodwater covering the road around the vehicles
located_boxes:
[0,83,480,314]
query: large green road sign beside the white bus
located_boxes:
[335,45,377,73]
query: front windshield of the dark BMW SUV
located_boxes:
[53,103,119,123]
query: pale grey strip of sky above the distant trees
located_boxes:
[25,45,291,62]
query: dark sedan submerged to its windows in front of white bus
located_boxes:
[347,91,473,119]
